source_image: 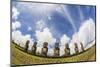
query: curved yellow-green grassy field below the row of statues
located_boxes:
[11,43,96,65]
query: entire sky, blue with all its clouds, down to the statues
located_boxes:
[12,1,96,55]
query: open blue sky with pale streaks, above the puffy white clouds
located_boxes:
[12,1,95,45]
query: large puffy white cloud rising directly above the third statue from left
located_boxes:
[35,28,56,45]
